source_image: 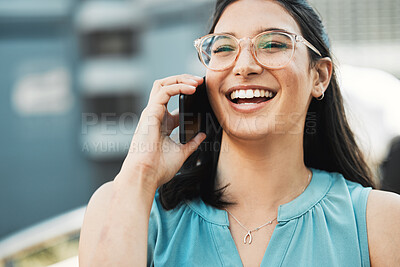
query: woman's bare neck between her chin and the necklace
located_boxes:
[216,132,310,212]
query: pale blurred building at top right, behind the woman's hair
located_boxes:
[310,0,400,78]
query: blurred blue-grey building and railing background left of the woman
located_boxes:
[0,0,213,266]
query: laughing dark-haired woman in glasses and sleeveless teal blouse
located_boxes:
[80,0,400,266]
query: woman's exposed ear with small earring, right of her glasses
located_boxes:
[311,57,333,98]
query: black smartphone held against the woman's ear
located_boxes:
[179,78,210,144]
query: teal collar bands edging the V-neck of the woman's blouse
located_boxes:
[187,168,332,267]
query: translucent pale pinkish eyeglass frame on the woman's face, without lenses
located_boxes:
[193,30,322,71]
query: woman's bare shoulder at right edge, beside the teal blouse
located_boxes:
[367,190,400,266]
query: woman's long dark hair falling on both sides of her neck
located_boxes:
[159,0,376,209]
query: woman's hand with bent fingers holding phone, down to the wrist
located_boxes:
[119,74,205,189]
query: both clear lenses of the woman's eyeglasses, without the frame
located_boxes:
[201,33,294,70]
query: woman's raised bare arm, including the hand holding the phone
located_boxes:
[79,75,205,267]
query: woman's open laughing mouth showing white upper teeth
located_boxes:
[227,89,276,105]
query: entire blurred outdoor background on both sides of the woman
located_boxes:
[0,0,400,267]
